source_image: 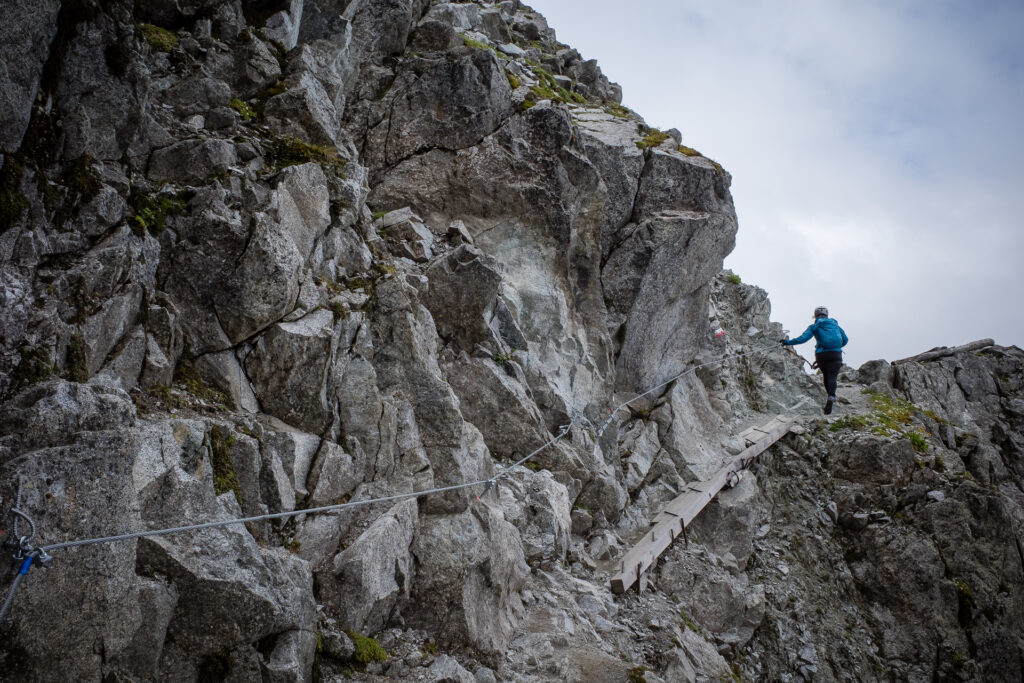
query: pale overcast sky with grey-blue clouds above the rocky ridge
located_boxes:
[527,0,1024,367]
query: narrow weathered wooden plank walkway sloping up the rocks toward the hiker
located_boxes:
[611,418,792,593]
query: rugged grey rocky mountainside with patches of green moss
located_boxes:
[0,0,1024,681]
